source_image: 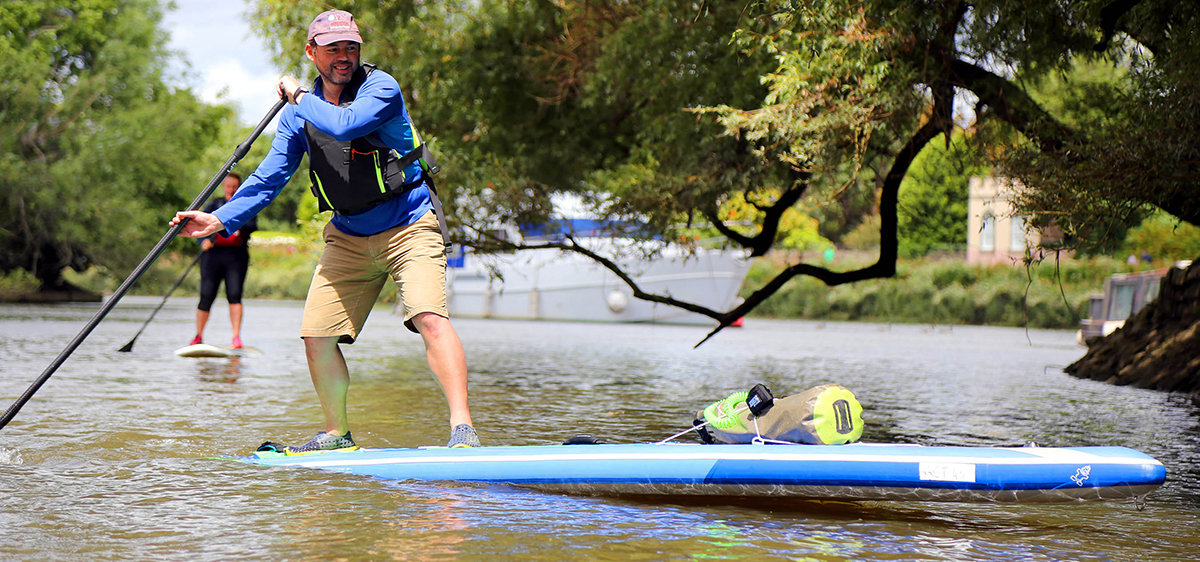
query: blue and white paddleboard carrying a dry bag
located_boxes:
[239,443,1166,502]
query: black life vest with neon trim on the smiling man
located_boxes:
[304,62,439,215]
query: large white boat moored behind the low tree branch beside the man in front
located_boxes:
[446,213,750,325]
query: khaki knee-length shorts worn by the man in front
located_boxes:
[300,211,450,343]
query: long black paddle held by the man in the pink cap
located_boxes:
[0,100,287,429]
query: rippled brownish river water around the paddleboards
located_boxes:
[0,298,1200,561]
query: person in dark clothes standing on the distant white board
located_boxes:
[191,172,258,349]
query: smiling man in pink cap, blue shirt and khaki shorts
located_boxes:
[170,10,479,454]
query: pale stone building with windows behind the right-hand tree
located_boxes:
[967,178,1042,265]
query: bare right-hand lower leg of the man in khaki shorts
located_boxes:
[413,312,473,429]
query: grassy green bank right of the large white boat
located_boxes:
[742,258,1132,329]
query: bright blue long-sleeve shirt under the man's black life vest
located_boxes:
[212,70,433,237]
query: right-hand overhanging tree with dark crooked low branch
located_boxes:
[696,0,1200,341]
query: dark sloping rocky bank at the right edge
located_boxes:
[1066,259,1200,394]
